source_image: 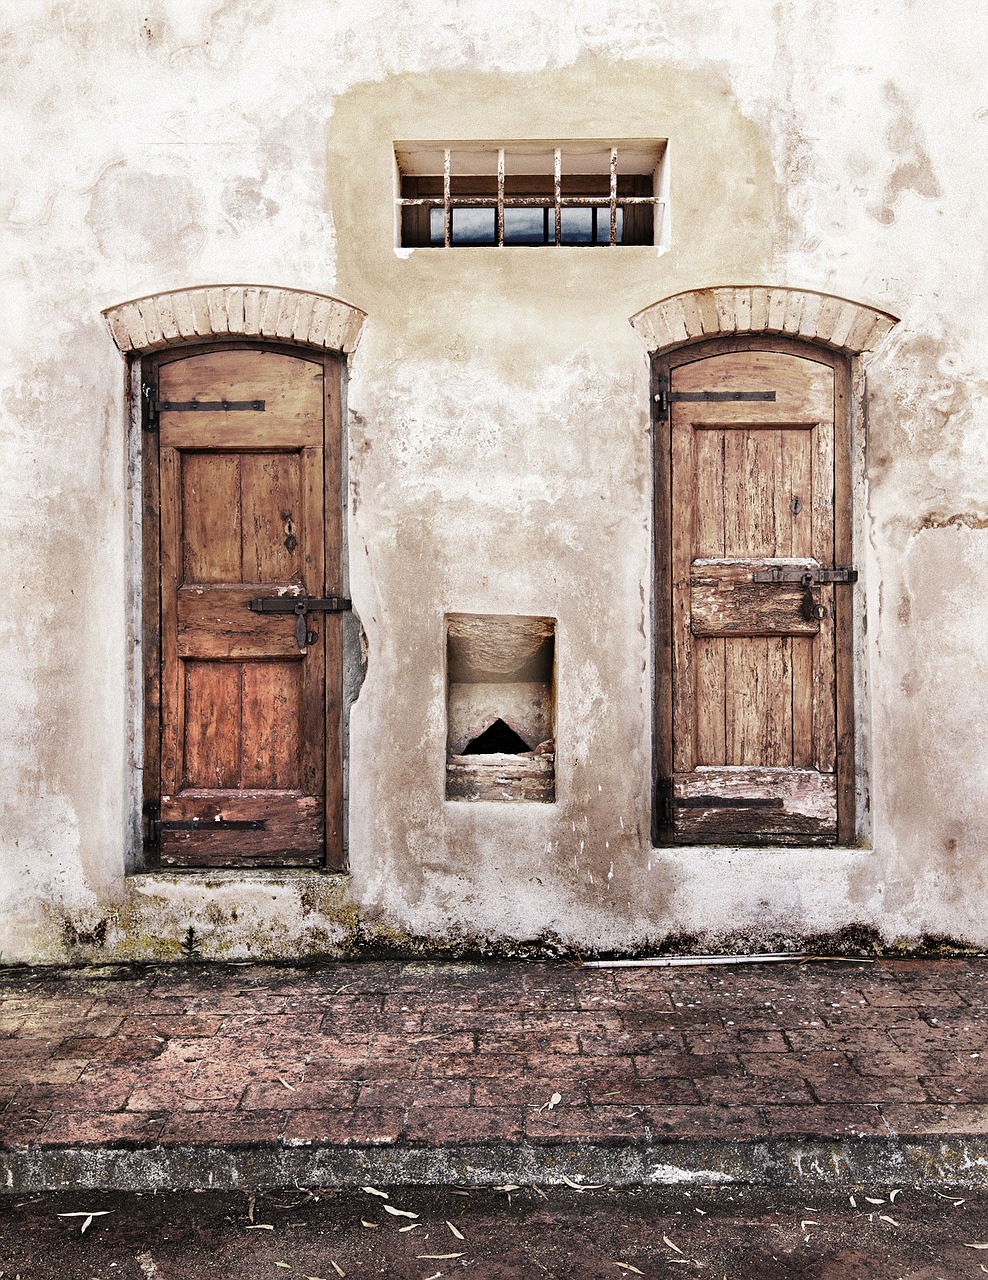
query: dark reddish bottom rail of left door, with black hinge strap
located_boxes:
[160,788,324,867]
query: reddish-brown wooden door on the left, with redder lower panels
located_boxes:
[145,348,346,867]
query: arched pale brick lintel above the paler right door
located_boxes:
[631,284,898,356]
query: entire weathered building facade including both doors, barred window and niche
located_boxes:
[0,0,988,961]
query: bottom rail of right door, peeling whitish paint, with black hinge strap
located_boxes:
[673,767,837,845]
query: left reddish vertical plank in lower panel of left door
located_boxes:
[182,660,243,788]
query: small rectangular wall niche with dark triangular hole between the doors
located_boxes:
[445,613,555,801]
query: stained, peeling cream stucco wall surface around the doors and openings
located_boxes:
[0,0,988,960]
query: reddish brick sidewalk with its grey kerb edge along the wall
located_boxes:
[0,960,988,1189]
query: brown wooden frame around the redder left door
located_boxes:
[135,335,349,876]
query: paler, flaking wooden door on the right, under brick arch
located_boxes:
[655,339,856,845]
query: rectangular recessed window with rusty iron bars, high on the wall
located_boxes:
[394,140,668,248]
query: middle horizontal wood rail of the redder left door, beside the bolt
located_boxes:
[177,584,308,659]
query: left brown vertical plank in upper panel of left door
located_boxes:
[182,452,241,582]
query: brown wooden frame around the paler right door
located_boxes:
[650,333,857,847]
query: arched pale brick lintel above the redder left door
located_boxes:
[102,284,366,355]
